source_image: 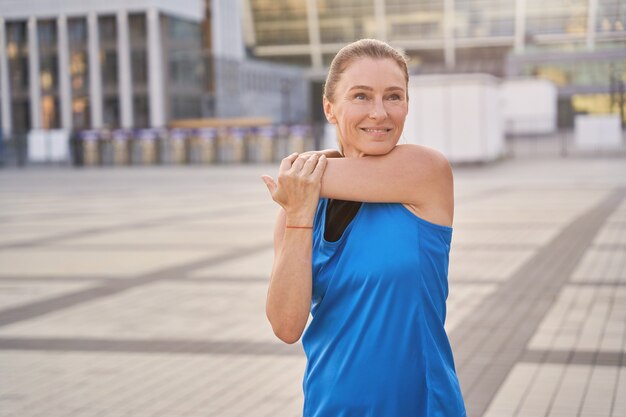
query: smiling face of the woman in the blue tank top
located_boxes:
[324,58,408,157]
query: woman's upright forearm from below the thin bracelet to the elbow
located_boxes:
[266,223,313,343]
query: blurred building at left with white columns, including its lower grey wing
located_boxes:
[0,0,310,138]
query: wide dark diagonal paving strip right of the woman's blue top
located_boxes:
[450,188,626,417]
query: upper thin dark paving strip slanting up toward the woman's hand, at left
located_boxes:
[0,203,268,250]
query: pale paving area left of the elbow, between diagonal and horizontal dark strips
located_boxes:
[0,281,279,344]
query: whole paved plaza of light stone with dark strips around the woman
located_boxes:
[0,156,626,417]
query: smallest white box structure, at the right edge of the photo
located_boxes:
[574,114,622,150]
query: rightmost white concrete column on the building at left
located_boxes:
[146,8,165,127]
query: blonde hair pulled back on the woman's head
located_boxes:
[324,39,409,102]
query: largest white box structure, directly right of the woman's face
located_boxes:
[404,74,504,163]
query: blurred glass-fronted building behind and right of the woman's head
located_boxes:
[242,0,626,125]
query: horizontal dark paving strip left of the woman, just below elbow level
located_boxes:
[0,337,304,356]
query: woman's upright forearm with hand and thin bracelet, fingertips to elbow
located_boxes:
[263,155,326,343]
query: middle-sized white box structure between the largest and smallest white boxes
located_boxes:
[500,78,558,135]
